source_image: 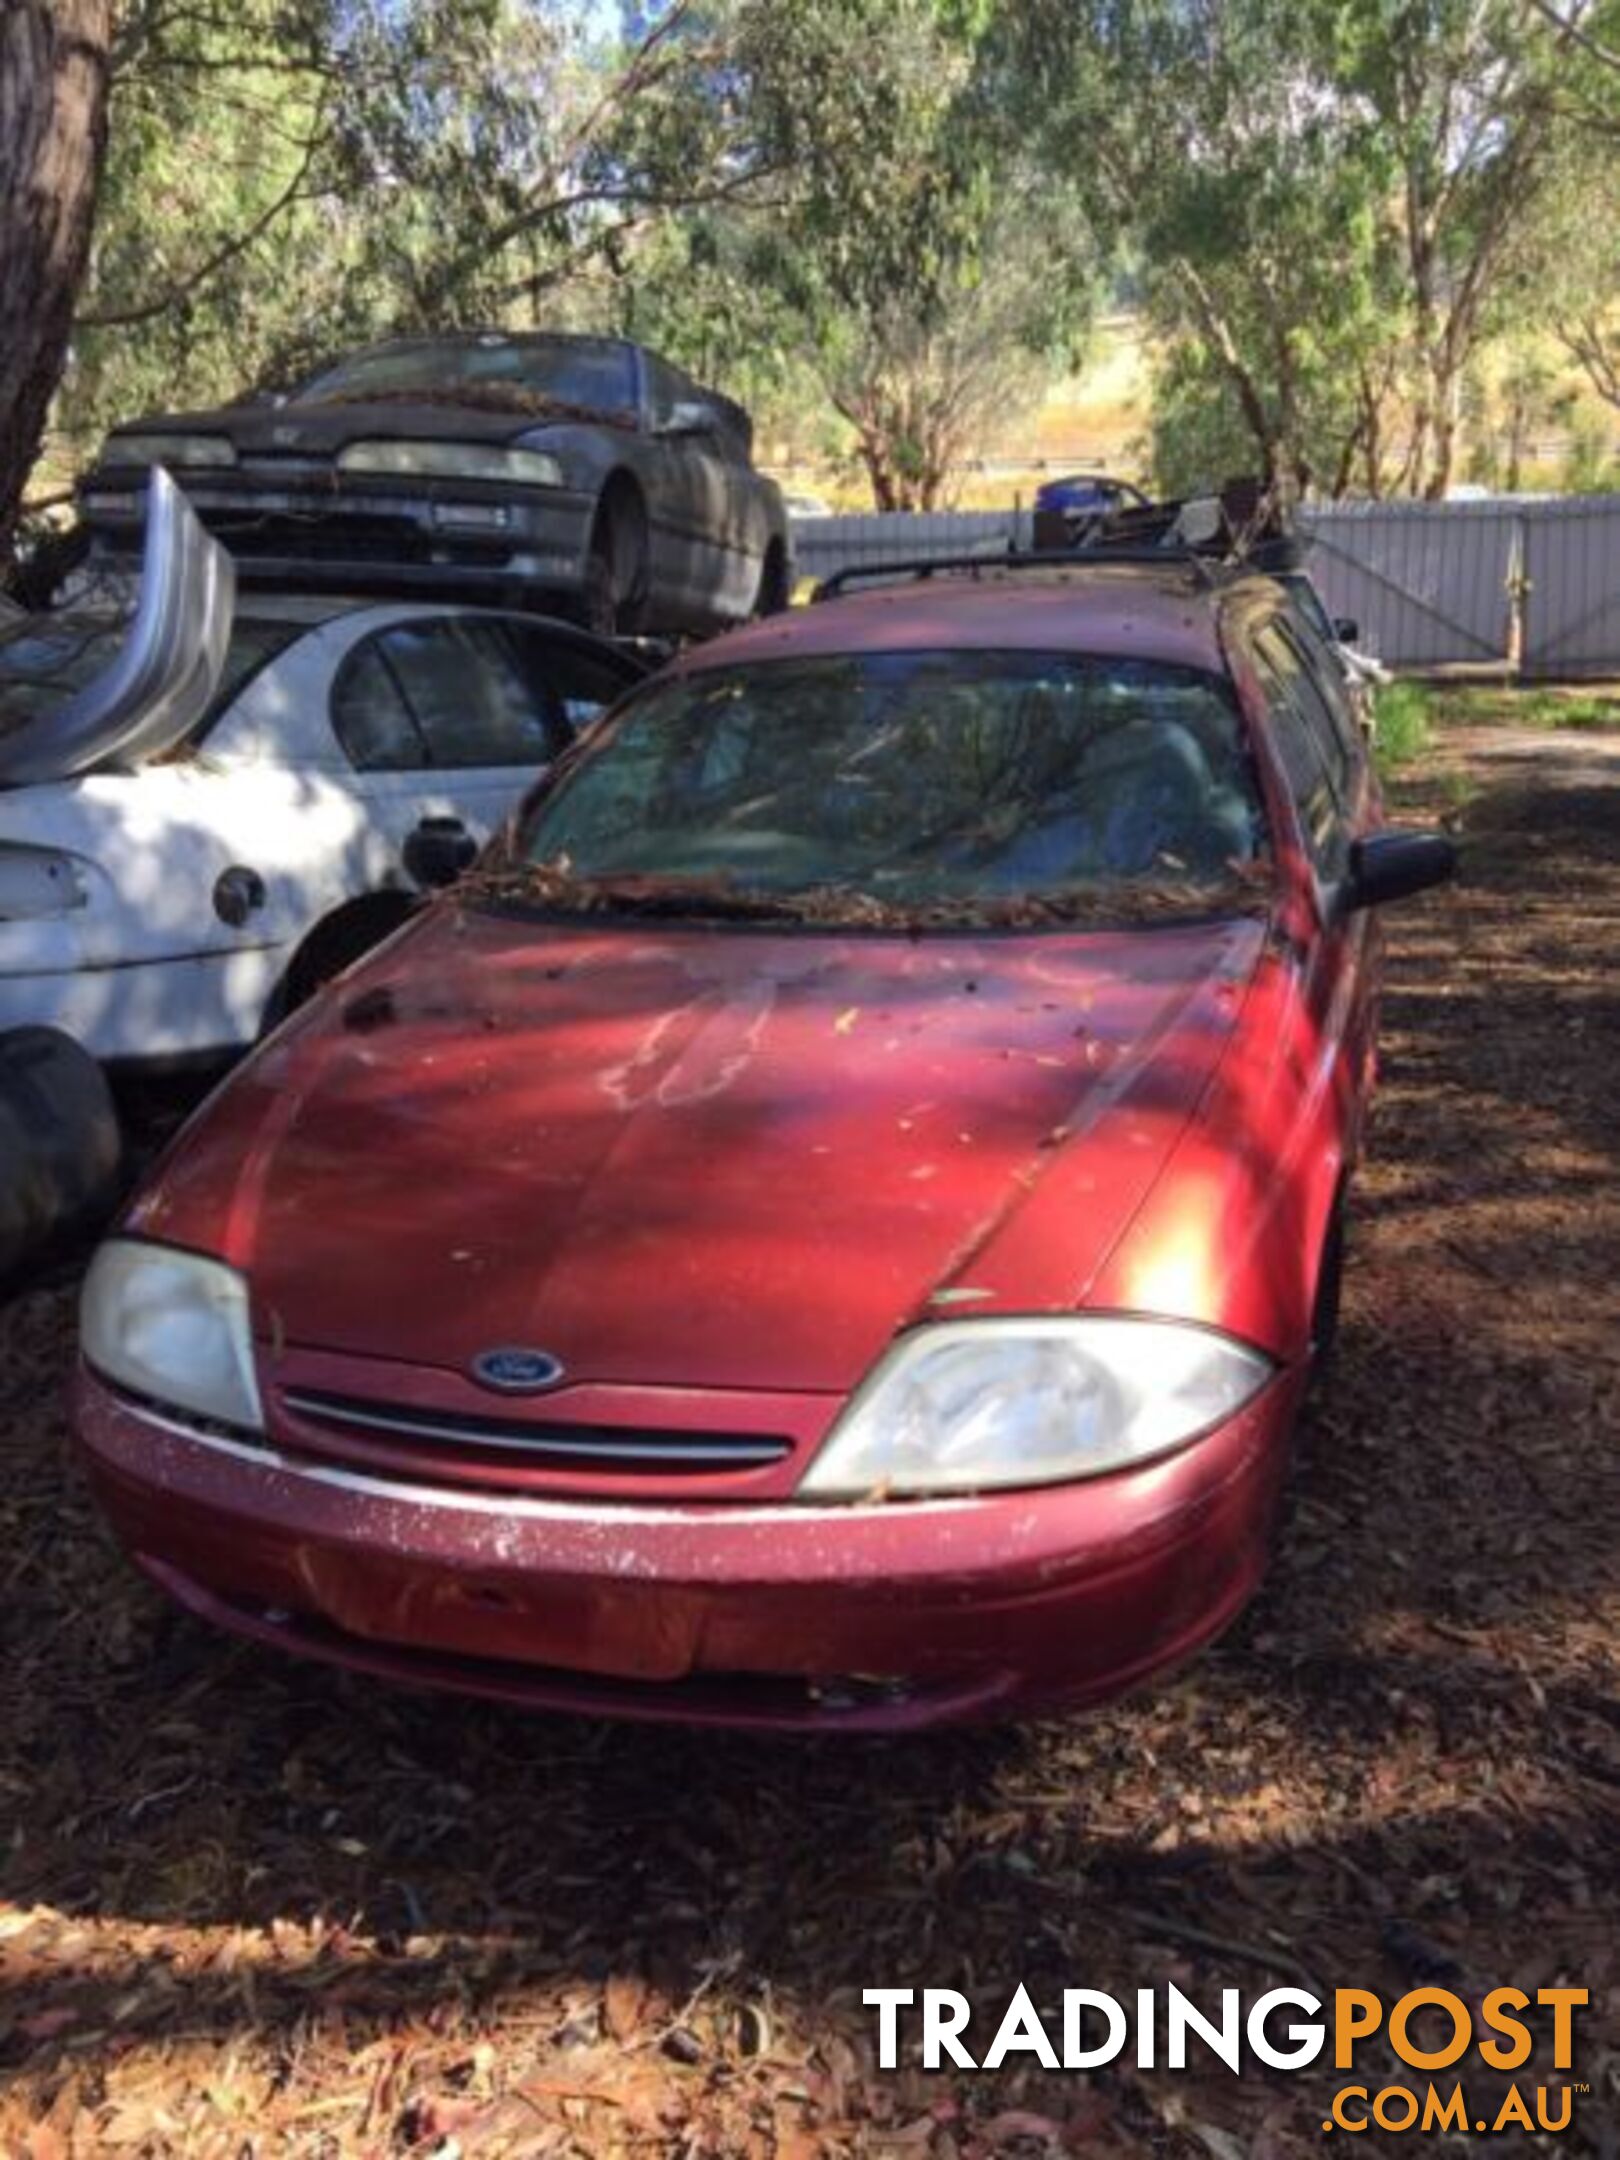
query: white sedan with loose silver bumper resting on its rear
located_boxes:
[0,473,646,1270]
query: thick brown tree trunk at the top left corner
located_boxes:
[0,0,112,555]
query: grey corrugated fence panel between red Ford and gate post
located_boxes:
[1302,503,1525,667]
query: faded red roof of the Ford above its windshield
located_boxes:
[680,559,1268,674]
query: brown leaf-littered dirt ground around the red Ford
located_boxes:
[0,730,1620,2160]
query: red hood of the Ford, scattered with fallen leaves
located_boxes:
[132,901,1264,1391]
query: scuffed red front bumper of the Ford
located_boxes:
[76,1372,1302,1730]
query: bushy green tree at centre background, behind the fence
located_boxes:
[624,0,1095,508]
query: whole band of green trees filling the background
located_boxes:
[19,0,1620,505]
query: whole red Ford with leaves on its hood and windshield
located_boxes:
[76,562,1452,1730]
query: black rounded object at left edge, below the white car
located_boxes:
[0,1028,123,1281]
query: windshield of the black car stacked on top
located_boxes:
[294,337,637,421]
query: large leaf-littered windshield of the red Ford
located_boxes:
[488,650,1268,924]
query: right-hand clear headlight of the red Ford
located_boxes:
[799,1315,1272,1499]
